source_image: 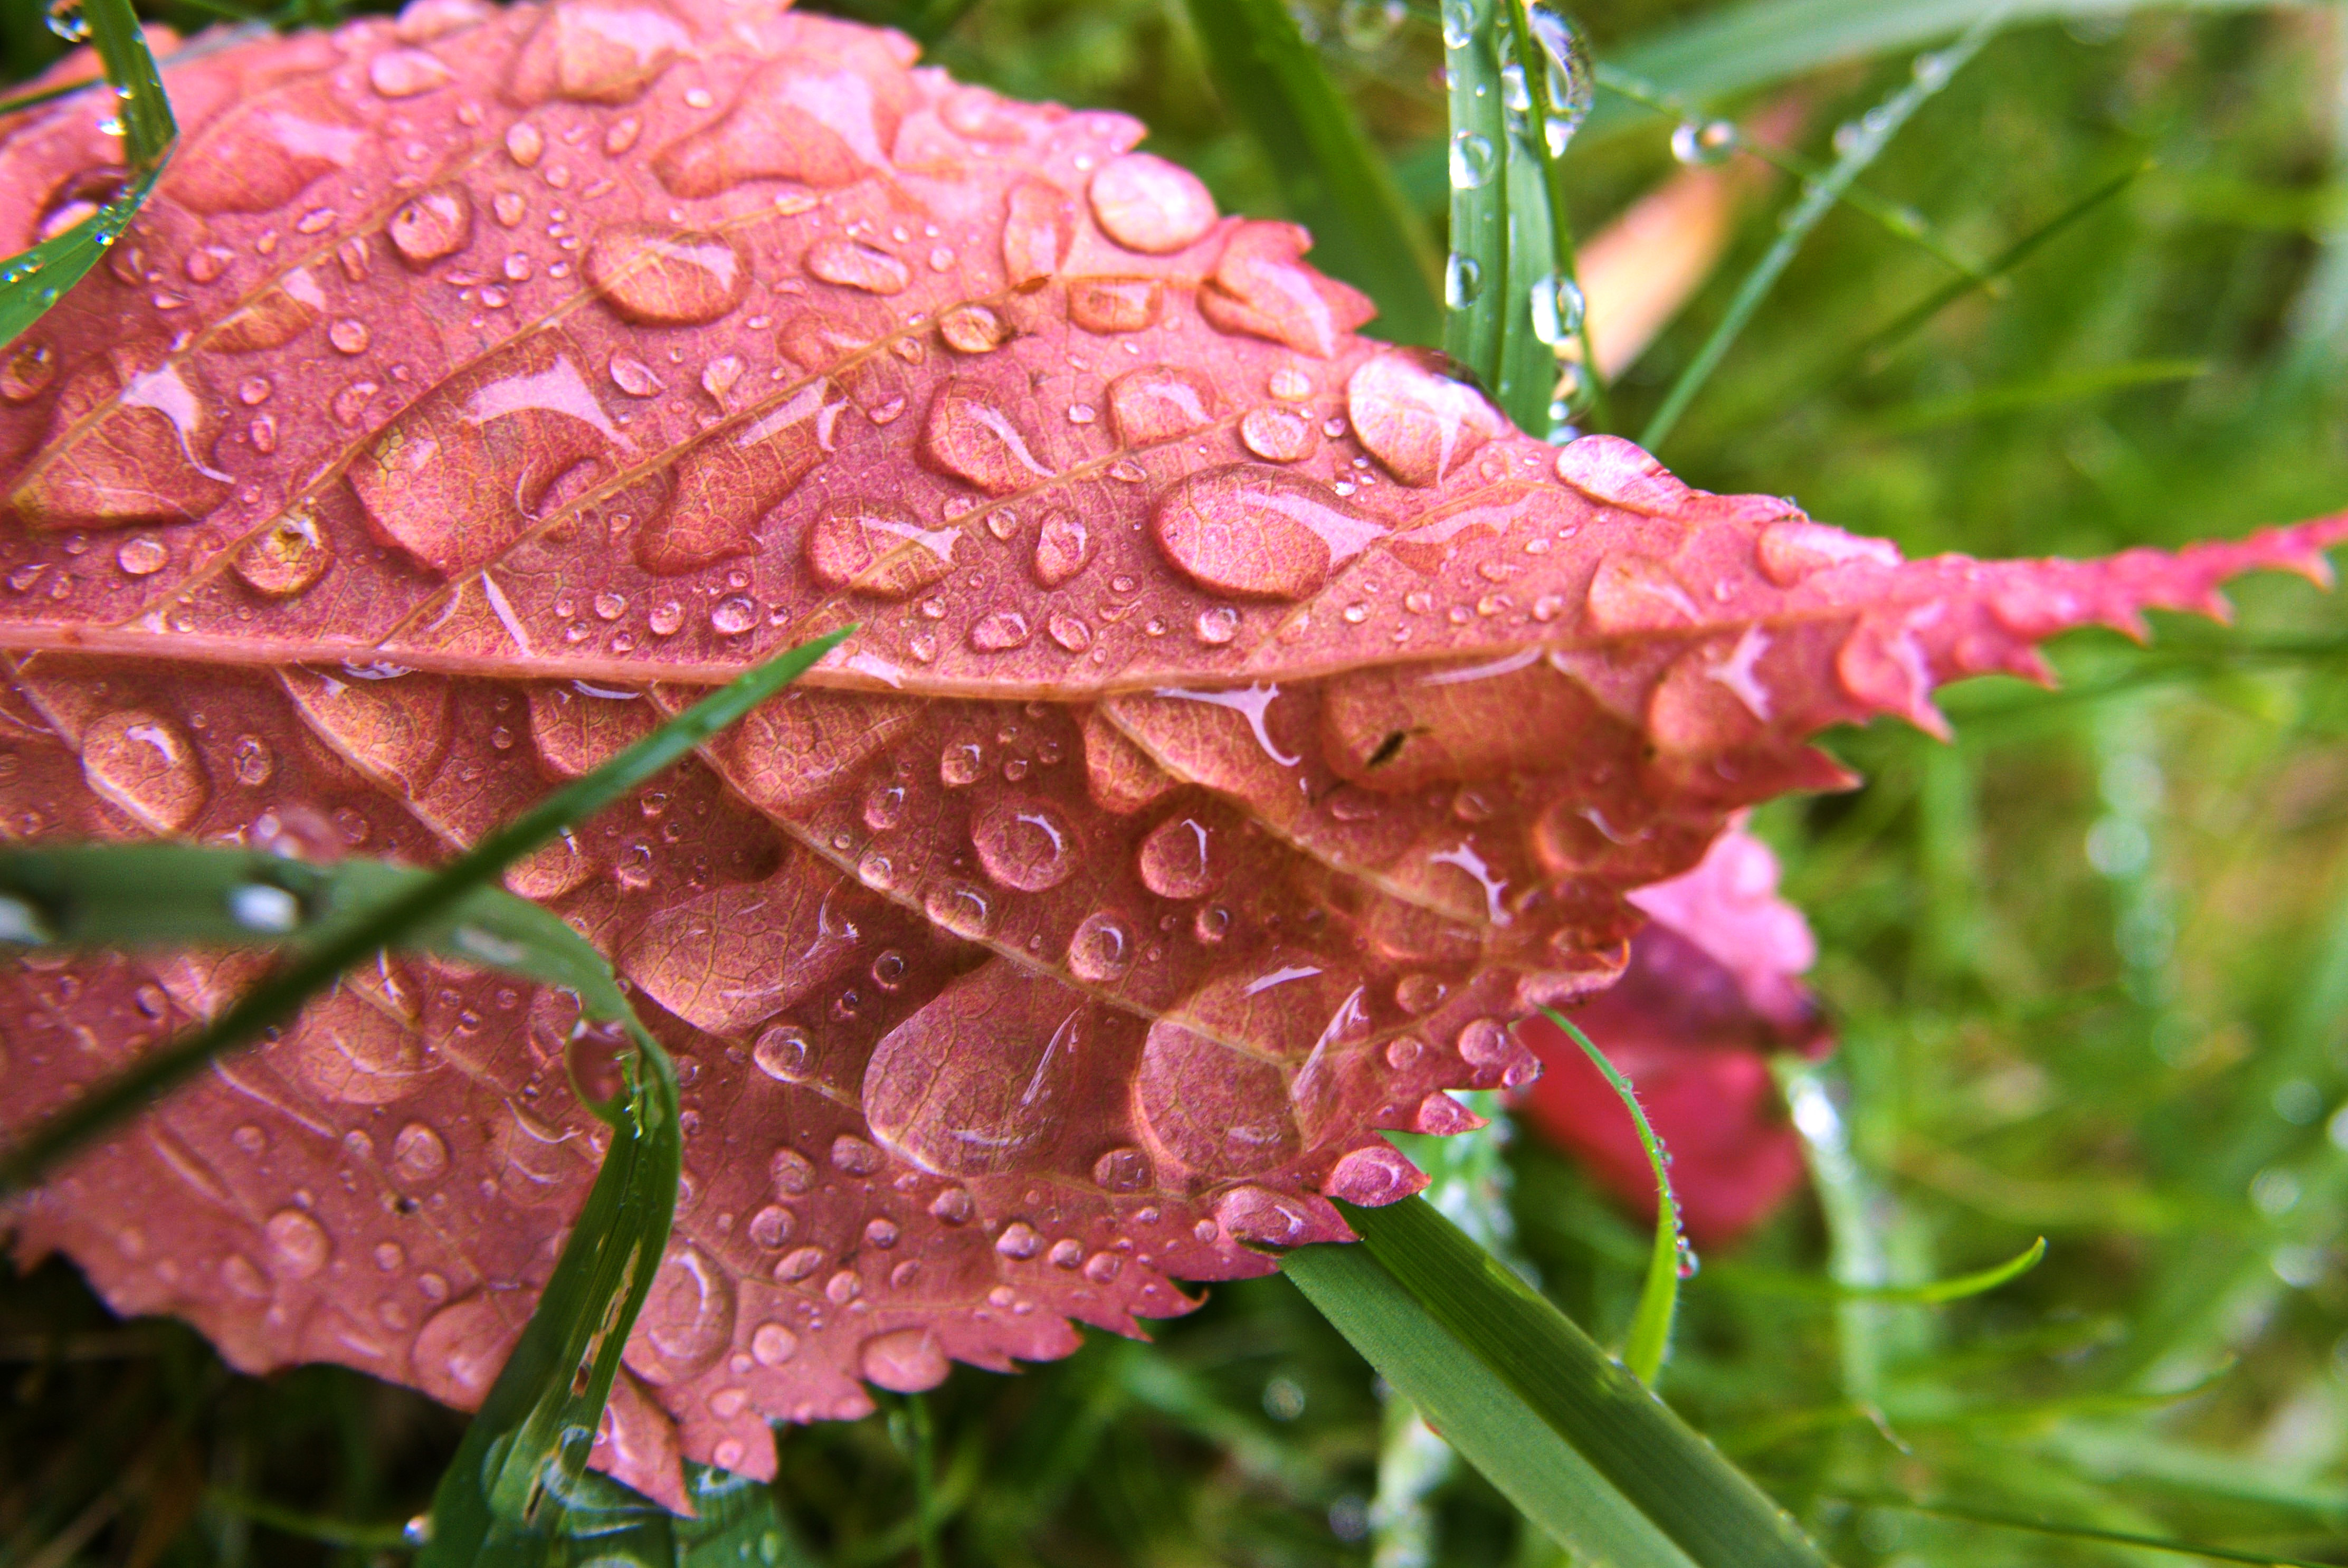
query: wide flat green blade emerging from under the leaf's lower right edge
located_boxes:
[1282,1197,1824,1568]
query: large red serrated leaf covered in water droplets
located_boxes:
[0,0,2341,1495]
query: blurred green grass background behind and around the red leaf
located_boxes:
[14,0,2348,1568]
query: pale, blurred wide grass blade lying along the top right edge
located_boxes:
[1590,0,2270,136]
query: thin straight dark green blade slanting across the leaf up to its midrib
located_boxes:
[0,627,854,1195]
